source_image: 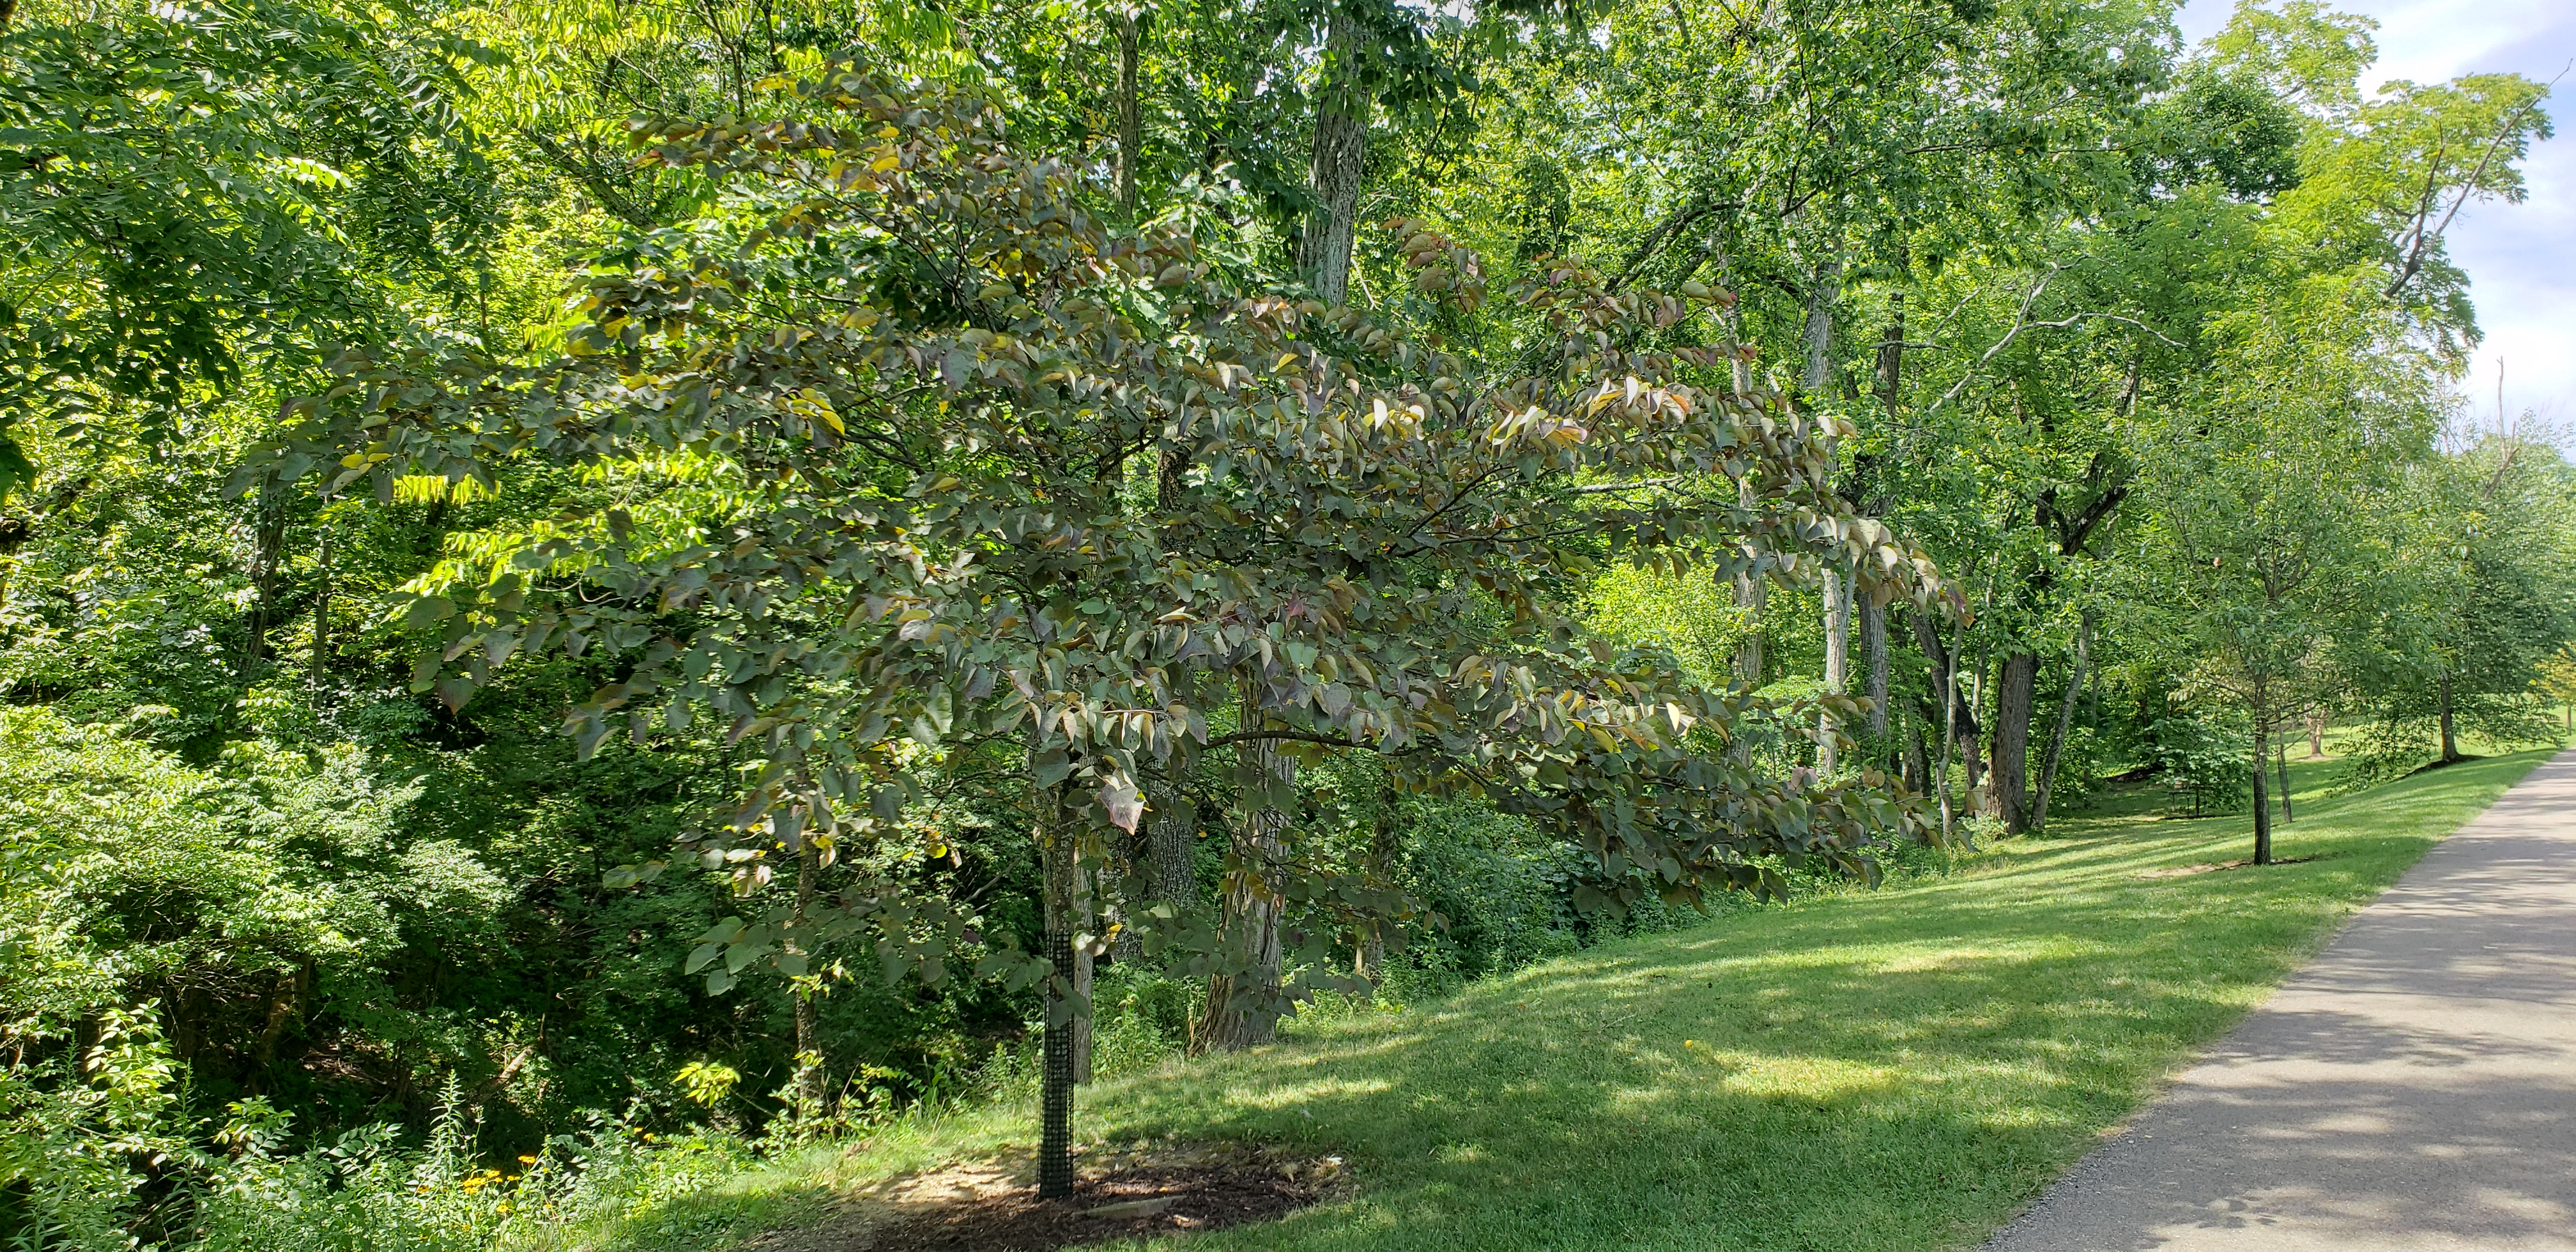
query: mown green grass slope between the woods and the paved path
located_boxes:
[611,752,2545,1249]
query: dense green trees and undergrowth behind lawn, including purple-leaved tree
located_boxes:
[0,0,2576,1249]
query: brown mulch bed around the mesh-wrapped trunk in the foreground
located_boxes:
[861,1149,1342,1252]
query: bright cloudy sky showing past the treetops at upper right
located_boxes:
[2182,0,2576,425]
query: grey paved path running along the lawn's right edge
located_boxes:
[1986,752,2576,1252]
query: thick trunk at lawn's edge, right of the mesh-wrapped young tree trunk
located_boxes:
[1198,683,1296,1048]
